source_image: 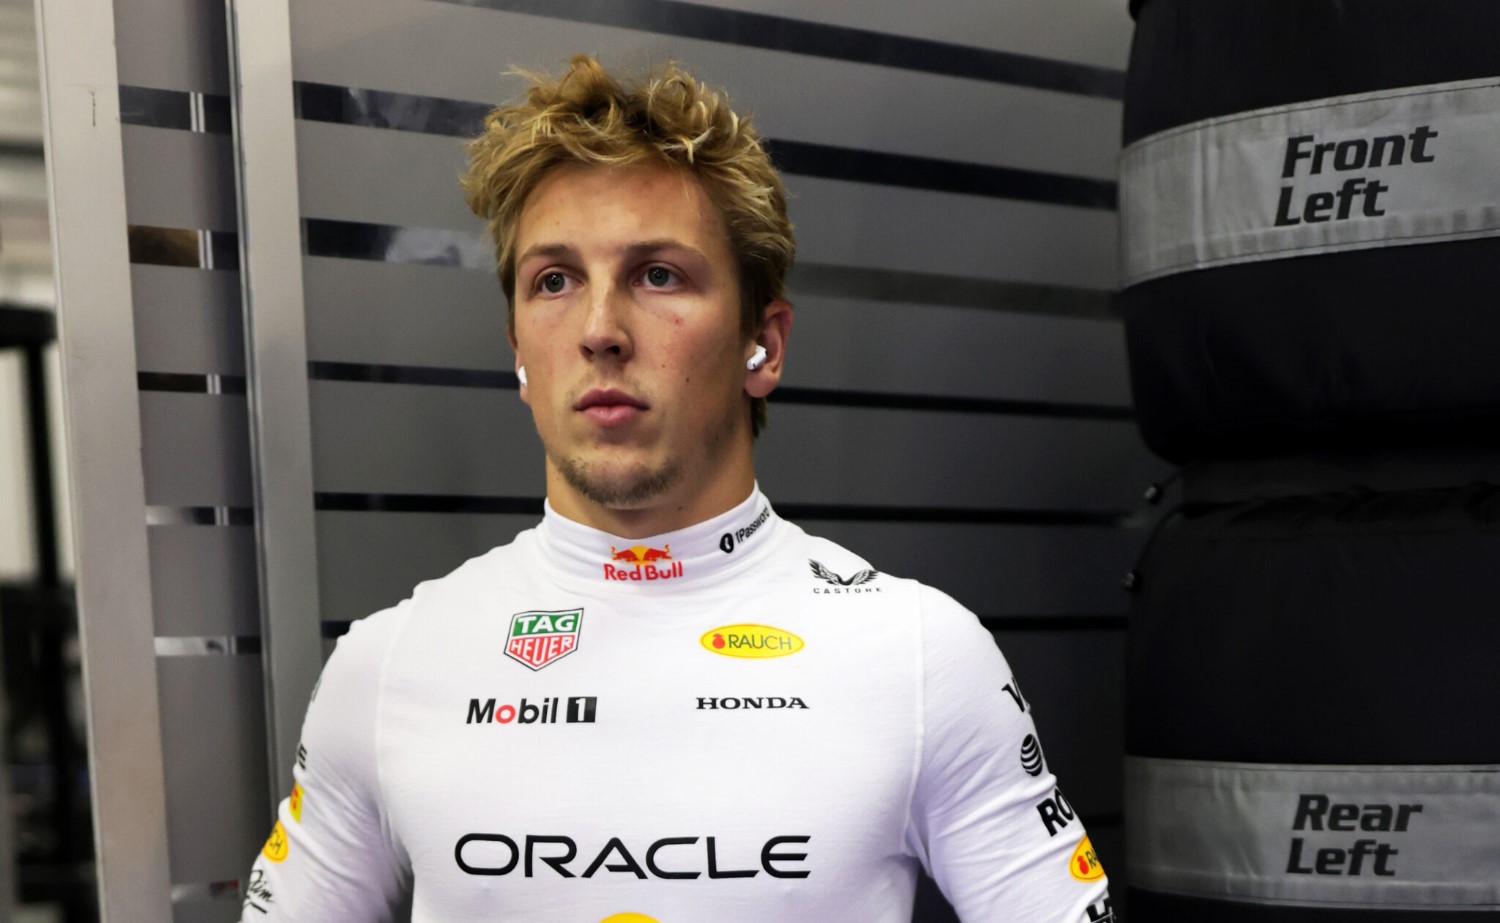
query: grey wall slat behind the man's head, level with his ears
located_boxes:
[303,257,1130,407]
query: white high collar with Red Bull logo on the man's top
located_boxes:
[536,485,782,593]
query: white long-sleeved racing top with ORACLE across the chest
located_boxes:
[243,491,1113,923]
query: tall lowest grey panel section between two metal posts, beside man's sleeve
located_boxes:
[156,657,270,888]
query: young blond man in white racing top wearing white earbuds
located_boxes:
[245,57,1112,923]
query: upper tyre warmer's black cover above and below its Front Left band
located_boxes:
[1121,0,1500,464]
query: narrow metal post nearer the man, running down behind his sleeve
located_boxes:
[227,0,323,791]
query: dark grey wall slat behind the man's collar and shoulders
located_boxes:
[318,510,1145,621]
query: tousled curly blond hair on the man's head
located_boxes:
[462,54,797,432]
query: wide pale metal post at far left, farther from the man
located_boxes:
[36,0,170,923]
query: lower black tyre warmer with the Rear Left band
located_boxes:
[1125,485,1500,923]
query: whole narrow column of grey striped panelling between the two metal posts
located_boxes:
[116,0,272,921]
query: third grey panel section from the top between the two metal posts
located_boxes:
[131,266,245,375]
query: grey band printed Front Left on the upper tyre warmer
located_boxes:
[1119,78,1500,285]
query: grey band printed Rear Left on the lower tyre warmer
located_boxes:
[1125,756,1500,911]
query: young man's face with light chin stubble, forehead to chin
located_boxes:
[515,165,753,509]
